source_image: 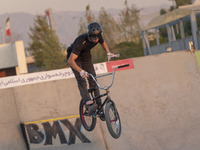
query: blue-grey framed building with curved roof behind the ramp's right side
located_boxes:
[142,0,200,55]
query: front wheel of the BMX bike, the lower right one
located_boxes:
[105,101,121,139]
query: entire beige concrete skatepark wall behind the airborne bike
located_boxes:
[0,51,200,150]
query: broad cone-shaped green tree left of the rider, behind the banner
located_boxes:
[28,15,65,70]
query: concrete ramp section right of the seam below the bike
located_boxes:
[101,51,200,150]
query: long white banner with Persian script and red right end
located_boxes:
[0,59,134,89]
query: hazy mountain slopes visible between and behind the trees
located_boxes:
[0,5,169,47]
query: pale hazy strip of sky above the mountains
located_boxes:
[0,0,172,14]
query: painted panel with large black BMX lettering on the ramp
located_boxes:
[21,118,91,149]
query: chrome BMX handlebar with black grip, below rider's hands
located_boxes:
[88,64,129,90]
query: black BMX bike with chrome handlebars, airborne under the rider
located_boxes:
[79,64,129,139]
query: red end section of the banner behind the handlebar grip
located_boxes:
[106,59,134,72]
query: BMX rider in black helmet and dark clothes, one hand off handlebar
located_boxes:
[67,22,118,117]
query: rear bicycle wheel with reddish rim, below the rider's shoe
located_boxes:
[79,100,96,131]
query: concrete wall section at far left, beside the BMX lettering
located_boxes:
[0,88,26,150]
